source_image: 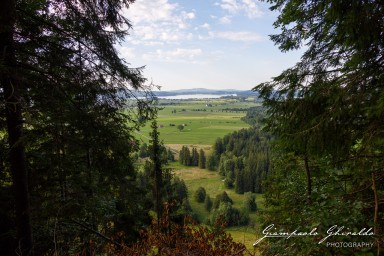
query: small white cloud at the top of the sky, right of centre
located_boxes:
[215,0,263,19]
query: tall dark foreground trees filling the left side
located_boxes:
[0,0,153,255]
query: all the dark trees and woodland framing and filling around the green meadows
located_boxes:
[0,0,384,256]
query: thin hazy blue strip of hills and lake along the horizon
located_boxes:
[153,88,257,97]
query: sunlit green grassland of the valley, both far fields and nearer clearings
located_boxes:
[134,98,263,252]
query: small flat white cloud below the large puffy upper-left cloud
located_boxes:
[142,48,203,63]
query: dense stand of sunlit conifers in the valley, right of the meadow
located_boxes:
[211,127,272,194]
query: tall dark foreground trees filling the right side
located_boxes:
[254,0,384,256]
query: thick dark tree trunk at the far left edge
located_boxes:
[0,0,32,255]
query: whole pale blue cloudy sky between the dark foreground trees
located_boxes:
[117,0,302,91]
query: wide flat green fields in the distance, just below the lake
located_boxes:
[135,99,256,145]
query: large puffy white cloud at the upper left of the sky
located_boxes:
[124,0,196,45]
